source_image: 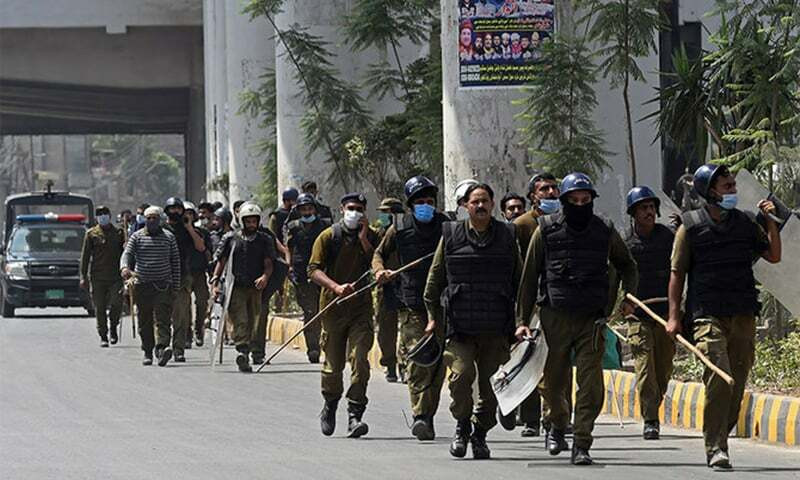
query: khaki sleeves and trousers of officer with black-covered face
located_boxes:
[517,221,638,449]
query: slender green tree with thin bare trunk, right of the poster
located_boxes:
[576,0,661,185]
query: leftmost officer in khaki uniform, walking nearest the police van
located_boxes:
[80,206,125,347]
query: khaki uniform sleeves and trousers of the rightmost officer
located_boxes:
[672,225,769,455]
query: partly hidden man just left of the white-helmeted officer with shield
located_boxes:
[183,202,214,348]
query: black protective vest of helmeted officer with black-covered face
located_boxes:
[539,214,611,315]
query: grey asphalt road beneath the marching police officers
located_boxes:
[0,309,800,480]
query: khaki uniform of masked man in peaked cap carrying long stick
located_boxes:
[308,224,378,408]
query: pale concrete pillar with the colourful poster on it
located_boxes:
[442,0,530,209]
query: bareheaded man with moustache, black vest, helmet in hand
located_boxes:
[424,183,522,459]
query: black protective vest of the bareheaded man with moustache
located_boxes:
[442,219,516,335]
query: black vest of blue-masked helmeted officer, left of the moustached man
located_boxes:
[395,213,448,311]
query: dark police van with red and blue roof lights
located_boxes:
[0,185,94,318]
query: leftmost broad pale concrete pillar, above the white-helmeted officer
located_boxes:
[225,1,275,202]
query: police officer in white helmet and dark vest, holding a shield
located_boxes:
[211,203,276,373]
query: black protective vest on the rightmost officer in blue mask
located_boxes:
[683,209,765,319]
